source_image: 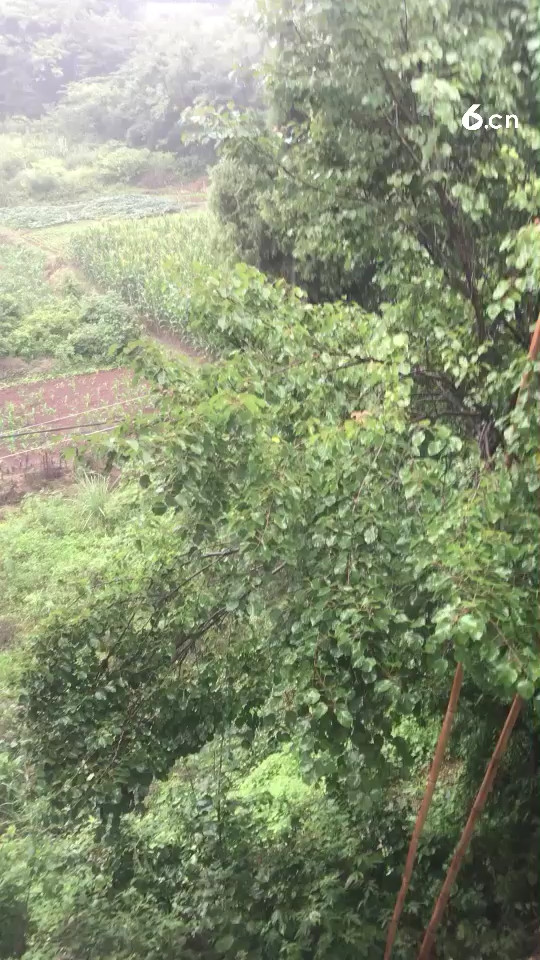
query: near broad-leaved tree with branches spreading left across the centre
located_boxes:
[19,267,540,960]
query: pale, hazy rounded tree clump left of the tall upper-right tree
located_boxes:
[55,8,257,158]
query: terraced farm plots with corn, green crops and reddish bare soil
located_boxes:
[0,184,206,503]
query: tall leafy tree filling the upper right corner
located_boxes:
[198,0,540,455]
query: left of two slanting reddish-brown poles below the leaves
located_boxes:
[384,663,463,960]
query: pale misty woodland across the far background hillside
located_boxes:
[0,0,257,174]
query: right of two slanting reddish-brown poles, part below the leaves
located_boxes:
[418,696,523,960]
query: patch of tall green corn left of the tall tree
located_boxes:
[70,212,218,332]
